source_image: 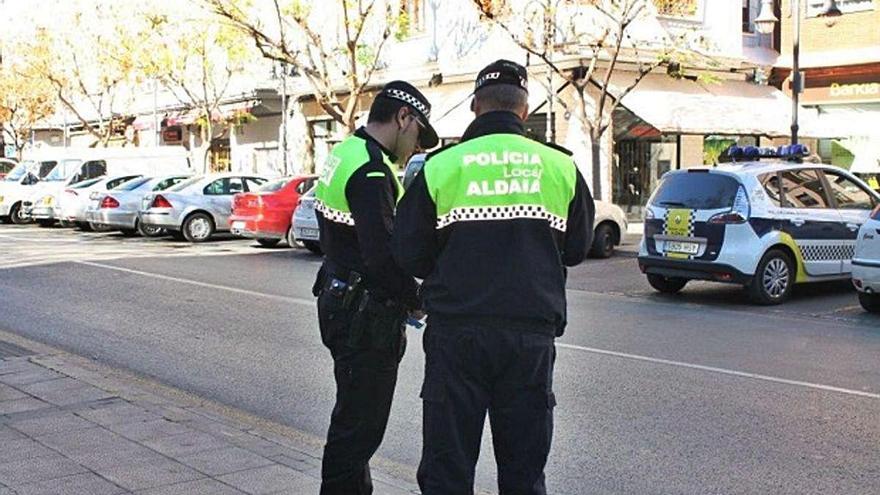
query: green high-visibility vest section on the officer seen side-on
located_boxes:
[315,136,403,226]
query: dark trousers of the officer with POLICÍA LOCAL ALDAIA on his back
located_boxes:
[418,317,556,495]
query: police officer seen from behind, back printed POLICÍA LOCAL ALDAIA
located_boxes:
[392,60,593,495]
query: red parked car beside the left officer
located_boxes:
[229,175,317,247]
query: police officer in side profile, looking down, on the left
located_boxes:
[314,81,437,495]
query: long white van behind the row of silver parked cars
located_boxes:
[10,146,192,221]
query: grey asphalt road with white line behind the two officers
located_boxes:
[0,226,880,494]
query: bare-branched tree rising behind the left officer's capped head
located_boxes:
[202,0,398,171]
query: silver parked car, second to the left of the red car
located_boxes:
[86,175,191,237]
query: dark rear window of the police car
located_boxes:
[651,172,739,210]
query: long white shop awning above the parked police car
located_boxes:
[615,74,839,138]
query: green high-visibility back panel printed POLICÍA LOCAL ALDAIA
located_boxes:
[424,134,577,231]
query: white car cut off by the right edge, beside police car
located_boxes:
[852,206,880,313]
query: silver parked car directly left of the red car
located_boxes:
[138,173,266,242]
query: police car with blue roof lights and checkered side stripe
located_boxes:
[638,145,880,304]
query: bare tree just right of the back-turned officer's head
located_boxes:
[474,0,700,198]
